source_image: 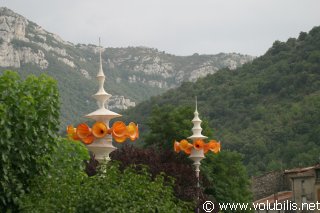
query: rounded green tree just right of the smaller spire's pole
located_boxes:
[201,150,252,212]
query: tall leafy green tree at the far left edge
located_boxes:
[0,71,59,211]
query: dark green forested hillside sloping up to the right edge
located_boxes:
[126,27,320,174]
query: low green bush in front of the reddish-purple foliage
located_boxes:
[77,166,192,213]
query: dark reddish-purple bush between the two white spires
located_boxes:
[110,145,203,201]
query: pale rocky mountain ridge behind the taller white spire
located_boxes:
[0,7,253,128]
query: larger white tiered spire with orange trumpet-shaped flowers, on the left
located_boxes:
[67,38,139,161]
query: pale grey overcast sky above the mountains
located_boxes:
[0,0,320,56]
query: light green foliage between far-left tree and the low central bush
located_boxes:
[20,138,89,212]
